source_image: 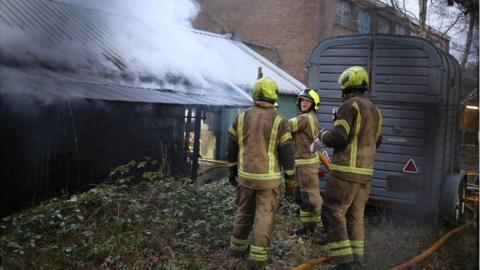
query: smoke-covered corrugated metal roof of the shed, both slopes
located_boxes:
[0,0,305,106]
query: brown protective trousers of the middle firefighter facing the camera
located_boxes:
[295,166,323,229]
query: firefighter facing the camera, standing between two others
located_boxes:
[287,88,326,244]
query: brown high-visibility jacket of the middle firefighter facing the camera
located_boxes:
[288,111,320,167]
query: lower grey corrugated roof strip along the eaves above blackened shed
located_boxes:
[0,66,251,107]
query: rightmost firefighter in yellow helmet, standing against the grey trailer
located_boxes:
[318,66,382,269]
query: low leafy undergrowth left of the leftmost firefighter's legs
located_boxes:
[0,157,235,269]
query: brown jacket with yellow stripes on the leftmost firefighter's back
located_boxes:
[227,101,295,189]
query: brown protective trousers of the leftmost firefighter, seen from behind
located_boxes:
[230,185,280,263]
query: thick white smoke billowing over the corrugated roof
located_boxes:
[0,0,256,100]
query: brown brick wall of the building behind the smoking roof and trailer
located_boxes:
[194,0,448,84]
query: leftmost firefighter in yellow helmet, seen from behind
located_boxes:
[227,77,295,269]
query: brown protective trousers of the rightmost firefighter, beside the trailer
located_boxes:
[324,175,370,264]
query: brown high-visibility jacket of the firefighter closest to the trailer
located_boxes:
[320,93,382,183]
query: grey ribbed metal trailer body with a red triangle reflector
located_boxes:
[309,34,460,212]
